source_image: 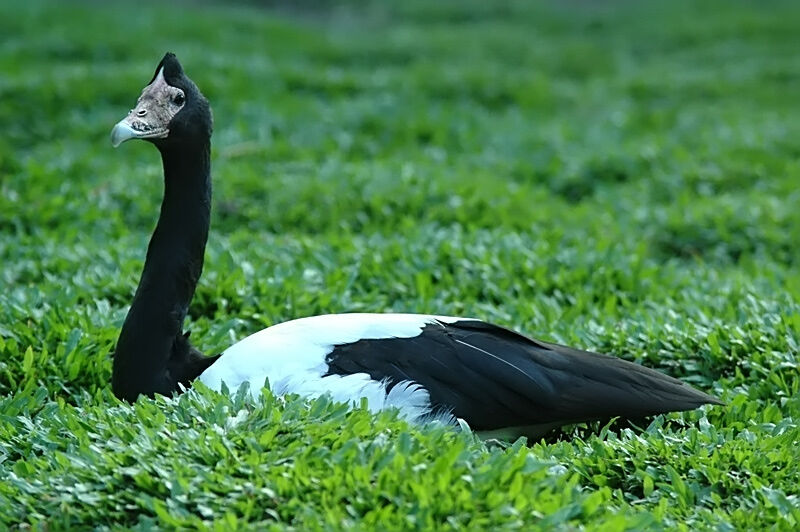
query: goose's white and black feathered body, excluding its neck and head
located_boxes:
[199,314,716,434]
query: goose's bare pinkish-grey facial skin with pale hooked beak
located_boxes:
[111,68,186,148]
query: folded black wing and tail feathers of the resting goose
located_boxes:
[326,320,721,430]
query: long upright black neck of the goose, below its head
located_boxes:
[112,139,211,400]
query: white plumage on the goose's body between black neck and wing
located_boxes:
[199,314,466,420]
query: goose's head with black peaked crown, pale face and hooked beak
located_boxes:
[111,53,212,147]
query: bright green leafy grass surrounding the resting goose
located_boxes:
[0,0,800,531]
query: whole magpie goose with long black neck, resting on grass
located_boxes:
[111,53,722,438]
